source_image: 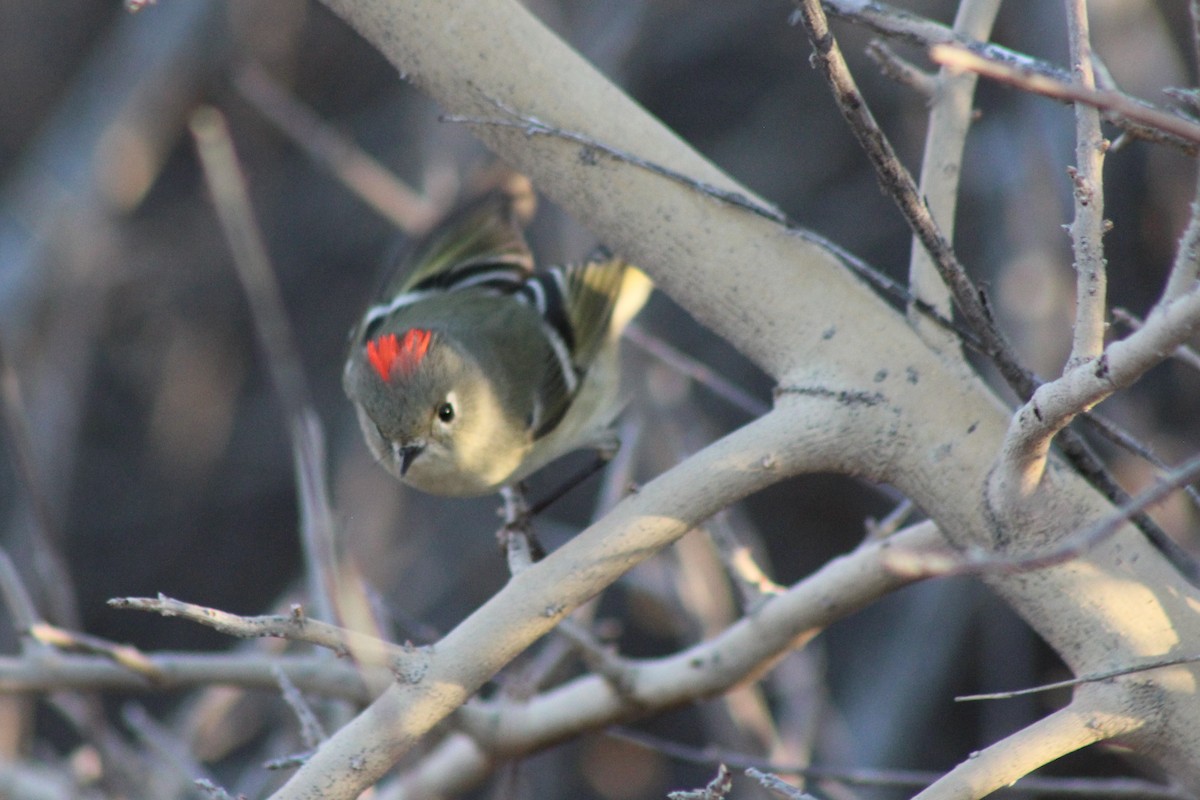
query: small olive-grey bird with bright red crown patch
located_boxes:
[343,184,652,497]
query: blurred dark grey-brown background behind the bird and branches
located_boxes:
[0,0,1200,800]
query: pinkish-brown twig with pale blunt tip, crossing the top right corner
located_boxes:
[929,44,1200,148]
